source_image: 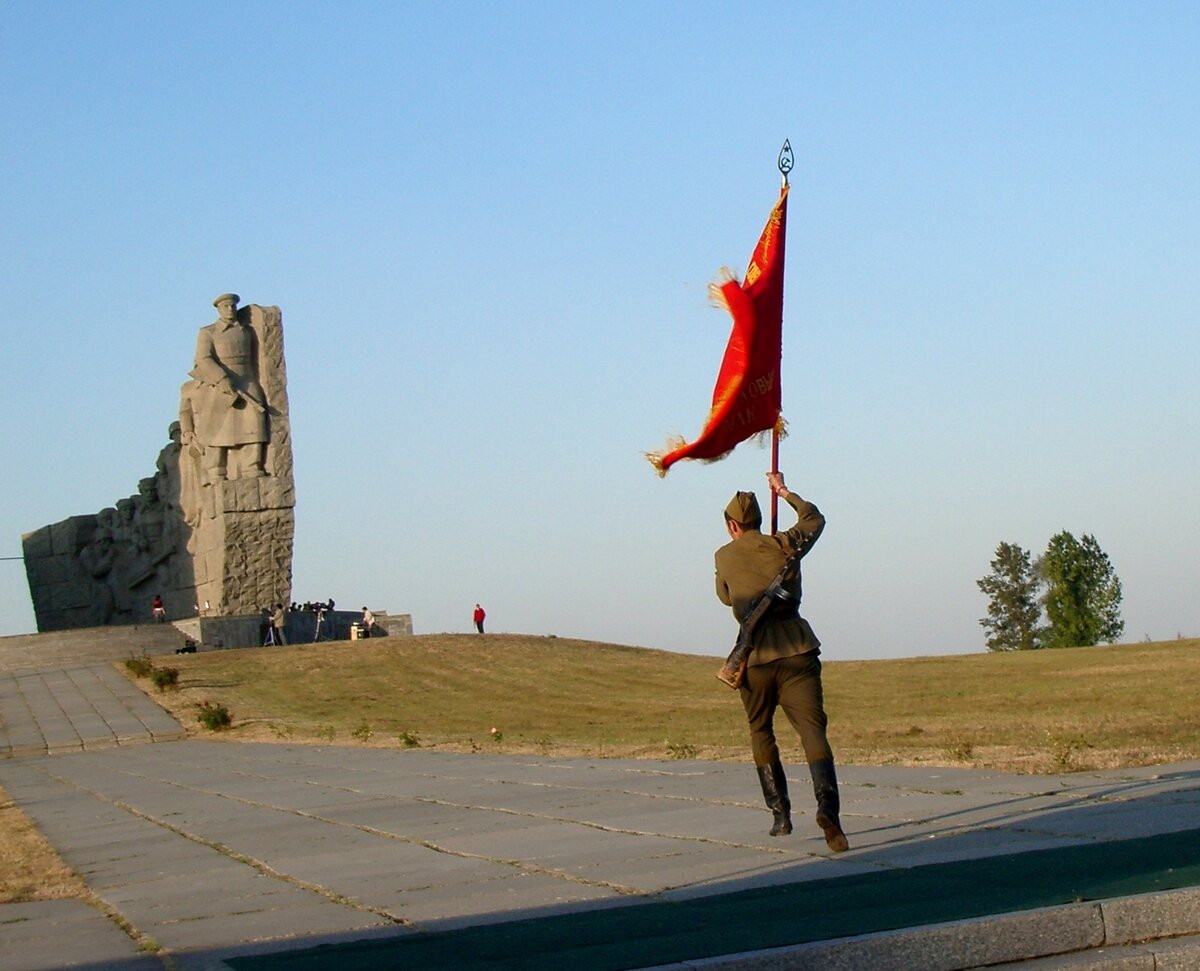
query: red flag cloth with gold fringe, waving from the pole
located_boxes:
[647,185,787,475]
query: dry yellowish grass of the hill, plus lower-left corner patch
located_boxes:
[0,634,1200,903]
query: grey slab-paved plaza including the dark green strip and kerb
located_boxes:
[0,643,1200,971]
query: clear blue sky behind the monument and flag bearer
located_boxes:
[0,0,1200,659]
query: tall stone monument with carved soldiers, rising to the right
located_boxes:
[23,293,295,631]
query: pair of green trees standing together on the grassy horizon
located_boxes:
[976,531,1124,651]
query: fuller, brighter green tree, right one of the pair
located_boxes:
[1034,531,1124,647]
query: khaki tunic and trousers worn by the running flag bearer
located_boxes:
[715,492,833,766]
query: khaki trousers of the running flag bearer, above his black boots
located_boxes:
[738,651,833,766]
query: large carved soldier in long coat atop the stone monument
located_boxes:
[181,293,269,482]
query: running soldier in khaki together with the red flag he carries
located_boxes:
[647,142,850,852]
